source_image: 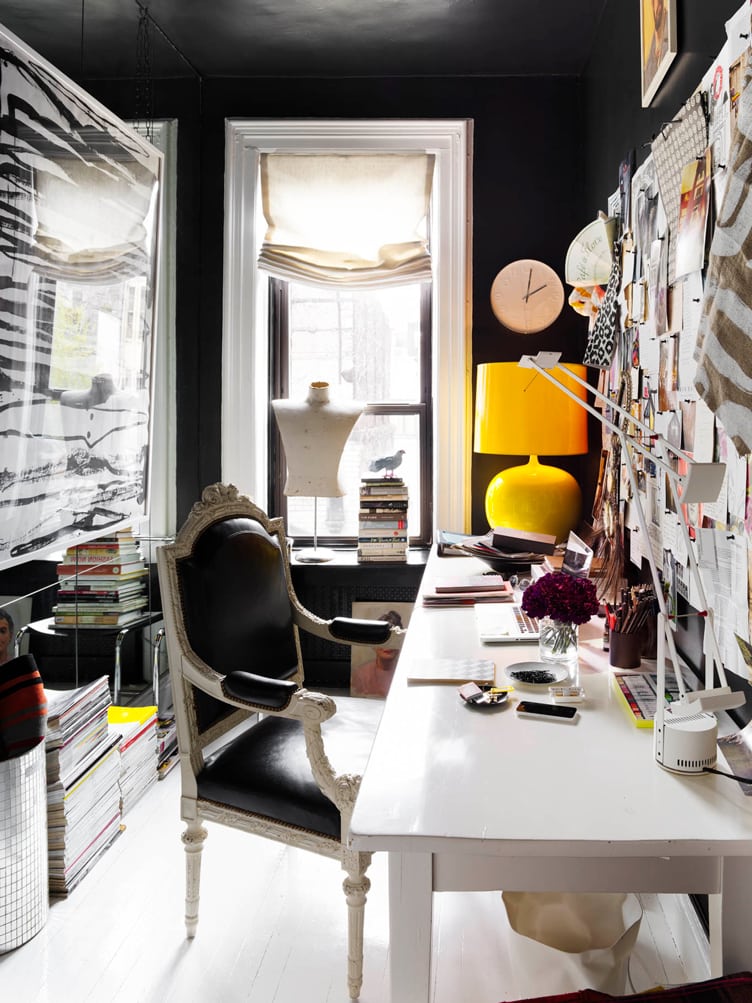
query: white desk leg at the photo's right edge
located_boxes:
[708,857,752,978]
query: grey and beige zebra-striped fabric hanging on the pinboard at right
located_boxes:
[695,47,752,456]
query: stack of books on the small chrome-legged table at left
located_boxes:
[53,530,148,628]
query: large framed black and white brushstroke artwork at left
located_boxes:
[0,27,161,568]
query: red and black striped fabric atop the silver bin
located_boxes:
[0,655,47,759]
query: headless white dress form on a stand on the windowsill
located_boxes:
[272,381,363,561]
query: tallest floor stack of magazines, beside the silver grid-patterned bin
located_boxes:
[45,676,120,896]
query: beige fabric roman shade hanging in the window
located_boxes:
[259,153,434,286]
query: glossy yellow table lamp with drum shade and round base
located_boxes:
[474,362,588,542]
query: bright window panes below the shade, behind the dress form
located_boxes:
[269,279,432,545]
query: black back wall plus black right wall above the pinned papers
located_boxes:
[16,0,740,553]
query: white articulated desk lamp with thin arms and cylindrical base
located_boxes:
[519,352,745,773]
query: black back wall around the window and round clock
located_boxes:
[85,77,588,533]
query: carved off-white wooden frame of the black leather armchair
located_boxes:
[157,483,404,999]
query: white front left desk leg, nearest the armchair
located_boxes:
[389,853,433,1003]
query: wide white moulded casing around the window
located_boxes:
[222,118,472,532]
